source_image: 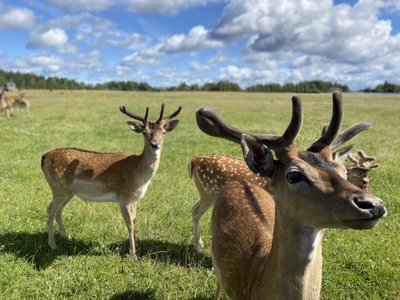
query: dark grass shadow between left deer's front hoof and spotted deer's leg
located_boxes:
[109,239,212,269]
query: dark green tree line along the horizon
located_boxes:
[0,70,400,93]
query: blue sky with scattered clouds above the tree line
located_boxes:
[0,0,400,90]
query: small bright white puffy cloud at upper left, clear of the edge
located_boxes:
[28,28,68,48]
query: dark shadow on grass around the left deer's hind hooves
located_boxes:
[0,232,101,270]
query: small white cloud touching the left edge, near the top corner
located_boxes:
[0,6,35,30]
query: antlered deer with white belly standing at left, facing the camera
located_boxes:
[42,104,181,257]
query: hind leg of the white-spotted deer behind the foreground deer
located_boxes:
[192,195,215,253]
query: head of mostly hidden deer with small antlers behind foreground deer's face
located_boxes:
[347,150,379,190]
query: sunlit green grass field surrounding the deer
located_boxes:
[0,91,400,299]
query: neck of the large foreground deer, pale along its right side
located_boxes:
[260,205,323,299]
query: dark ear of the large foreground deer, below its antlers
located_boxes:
[240,134,275,178]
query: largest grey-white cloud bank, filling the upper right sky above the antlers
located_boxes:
[211,0,400,64]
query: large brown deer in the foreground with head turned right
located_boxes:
[198,93,387,299]
